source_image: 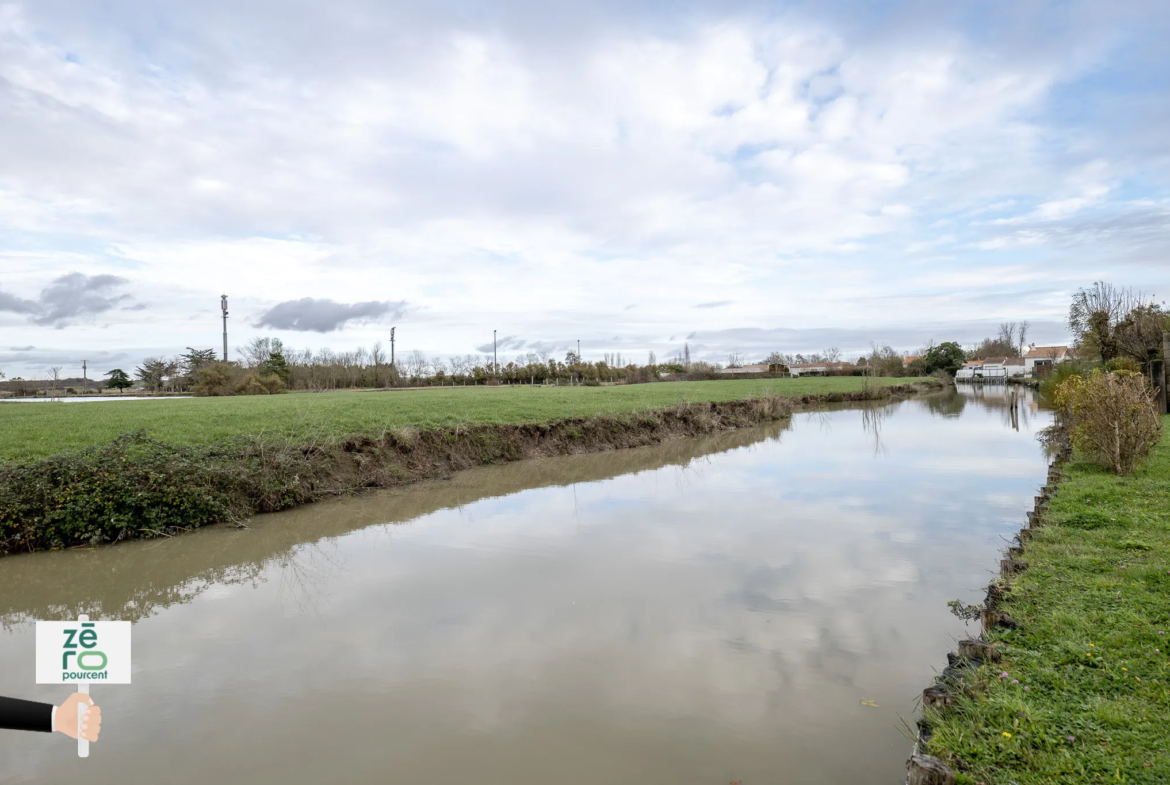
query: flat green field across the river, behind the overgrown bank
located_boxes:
[0,377,914,461]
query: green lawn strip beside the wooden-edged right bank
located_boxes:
[929,418,1170,785]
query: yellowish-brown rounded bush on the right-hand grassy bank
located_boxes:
[1053,371,1162,475]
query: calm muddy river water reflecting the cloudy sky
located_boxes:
[0,390,1048,785]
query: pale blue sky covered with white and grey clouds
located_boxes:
[0,0,1170,378]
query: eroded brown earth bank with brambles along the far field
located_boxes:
[0,380,941,553]
